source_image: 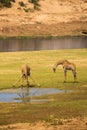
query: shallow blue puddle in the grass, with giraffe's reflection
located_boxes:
[0,88,69,102]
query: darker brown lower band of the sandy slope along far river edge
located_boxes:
[0,21,87,37]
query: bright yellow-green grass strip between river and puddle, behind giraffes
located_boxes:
[0,49,87,89]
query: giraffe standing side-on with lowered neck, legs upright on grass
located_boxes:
[53,60,77,82]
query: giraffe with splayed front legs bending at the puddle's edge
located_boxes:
[13,64,40,86]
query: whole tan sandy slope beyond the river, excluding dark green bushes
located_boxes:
[0,0,87,36]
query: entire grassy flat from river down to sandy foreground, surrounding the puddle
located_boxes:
[0,49,87,125]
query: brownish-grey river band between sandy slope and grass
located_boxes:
[0,36,87,52]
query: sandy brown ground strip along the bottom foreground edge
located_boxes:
[0,118,87,130]
